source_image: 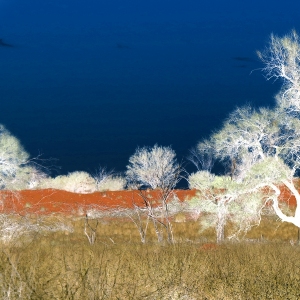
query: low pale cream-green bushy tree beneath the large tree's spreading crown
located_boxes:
[189,171,269,243]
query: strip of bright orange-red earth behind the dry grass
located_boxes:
[0,187,296,215]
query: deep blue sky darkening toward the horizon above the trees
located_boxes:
[0,0,300,178]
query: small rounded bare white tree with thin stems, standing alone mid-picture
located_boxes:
[126,145,181,243]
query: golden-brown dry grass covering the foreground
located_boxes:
[0,214,300,300]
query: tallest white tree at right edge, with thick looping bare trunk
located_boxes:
[254,30,300,228]
